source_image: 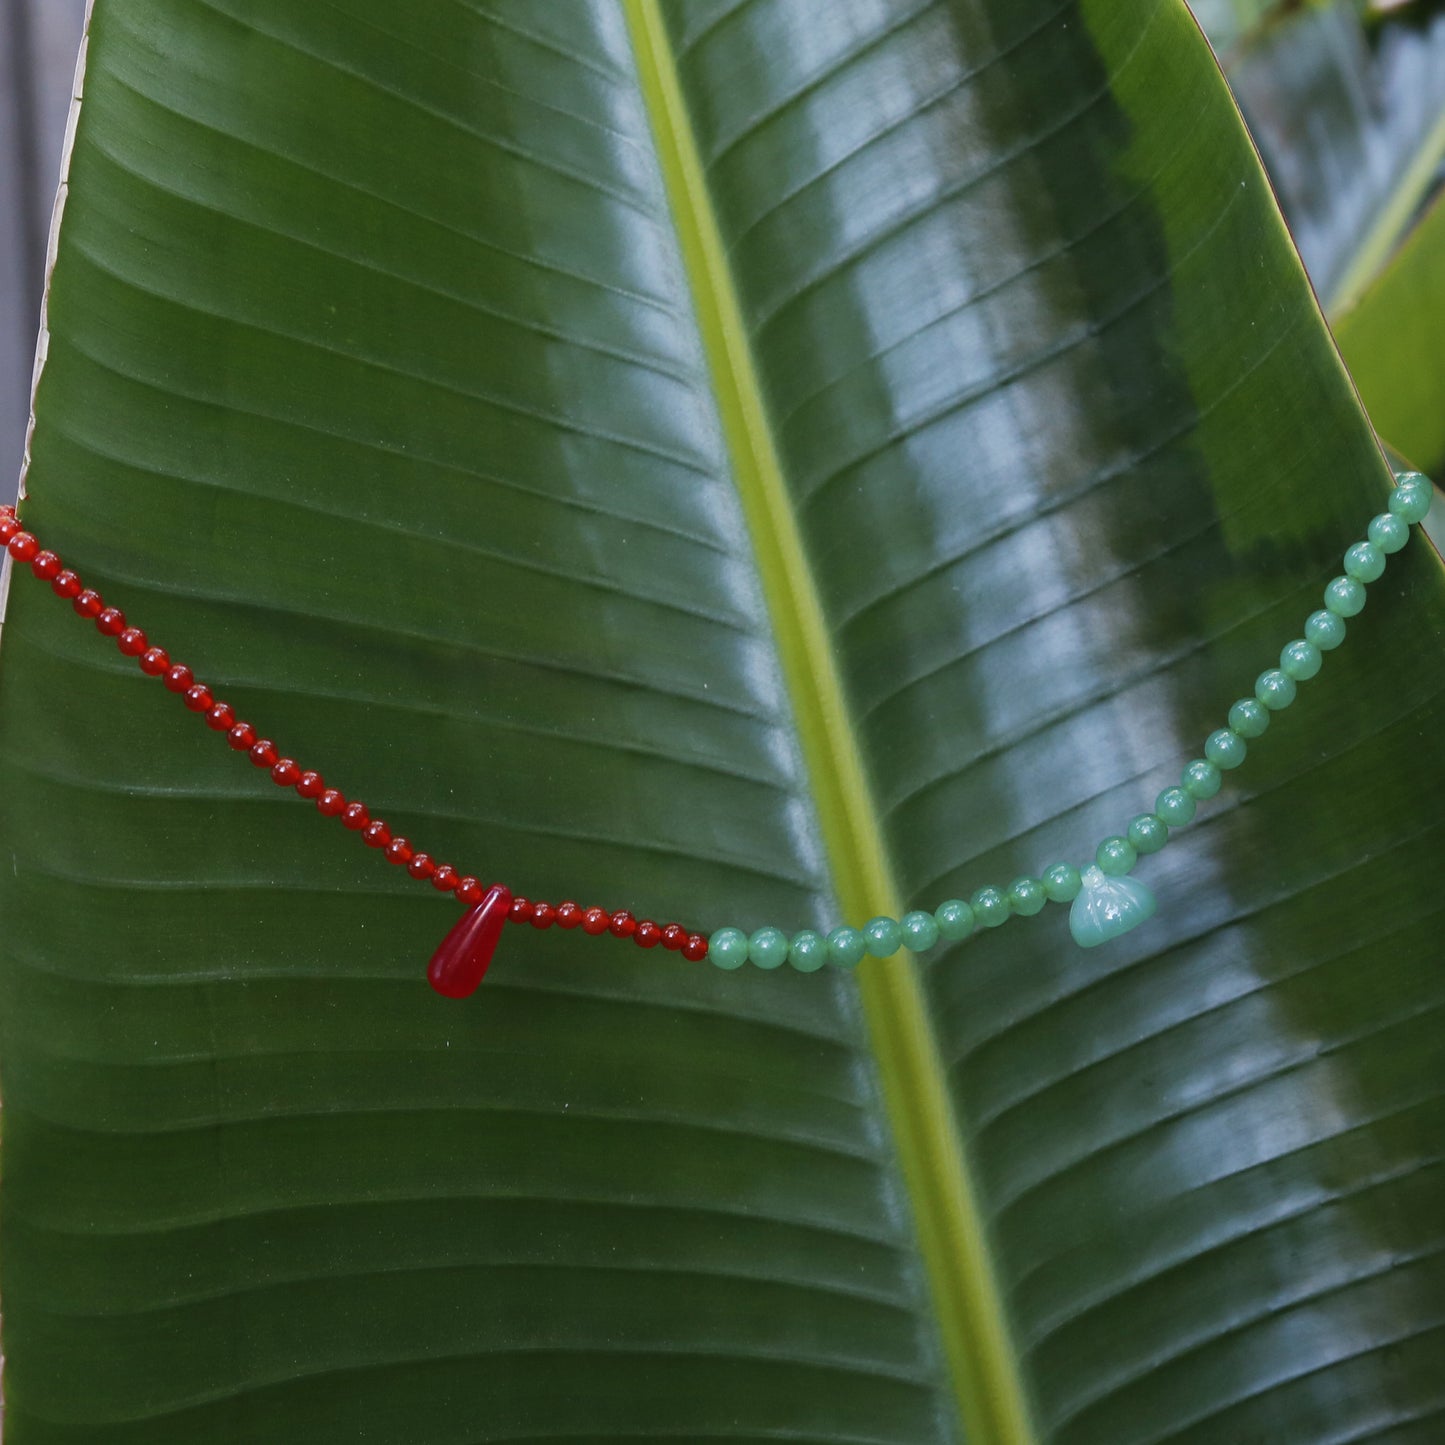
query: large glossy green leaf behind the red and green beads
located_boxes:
[0,0,1445,1445]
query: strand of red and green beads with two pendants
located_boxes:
[0,471,1433,998]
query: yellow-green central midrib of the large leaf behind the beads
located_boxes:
[624,0,1035,1445]
